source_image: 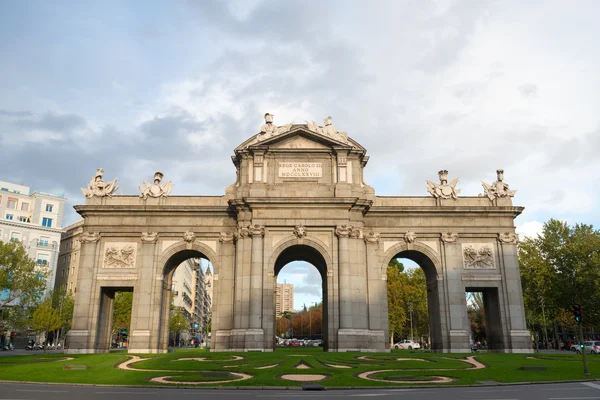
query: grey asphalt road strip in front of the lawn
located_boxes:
[0,382,600,400]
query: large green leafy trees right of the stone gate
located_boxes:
[519,219,600,330]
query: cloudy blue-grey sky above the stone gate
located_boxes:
[0,0,600,308]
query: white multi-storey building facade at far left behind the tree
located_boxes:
[0,181,67,296]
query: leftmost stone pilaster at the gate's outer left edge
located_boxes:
[65,232,100,354]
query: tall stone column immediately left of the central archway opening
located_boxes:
[246,225,265,349]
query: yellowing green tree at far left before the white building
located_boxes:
[0,240,46,332]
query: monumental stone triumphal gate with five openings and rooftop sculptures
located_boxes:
[67,114,530,353]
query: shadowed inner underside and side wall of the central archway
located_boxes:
[273,244,329,351]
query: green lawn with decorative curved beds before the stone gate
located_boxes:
[0,348,600,387]
